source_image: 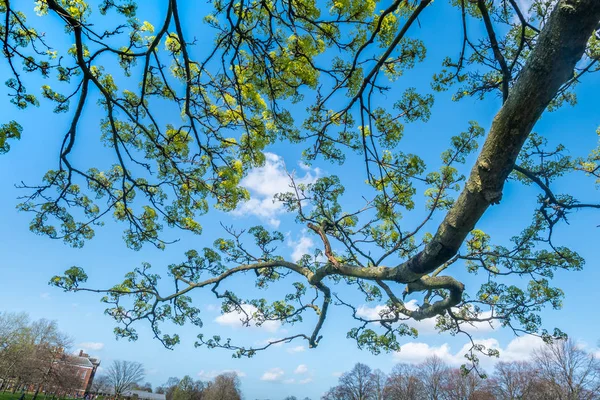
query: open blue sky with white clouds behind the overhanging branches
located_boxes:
[0,1,600,399]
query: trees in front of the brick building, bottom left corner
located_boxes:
[0,312,81,400]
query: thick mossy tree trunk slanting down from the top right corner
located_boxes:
[394,0,600,282]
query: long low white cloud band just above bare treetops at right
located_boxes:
[394,335,543,368]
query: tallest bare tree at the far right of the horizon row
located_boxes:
[533,339,600,400]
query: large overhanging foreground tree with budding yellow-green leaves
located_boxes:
[0,0,600,361]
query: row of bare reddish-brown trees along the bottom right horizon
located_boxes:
[322,340,600,400]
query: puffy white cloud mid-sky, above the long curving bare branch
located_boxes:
[233,153,321,228]
